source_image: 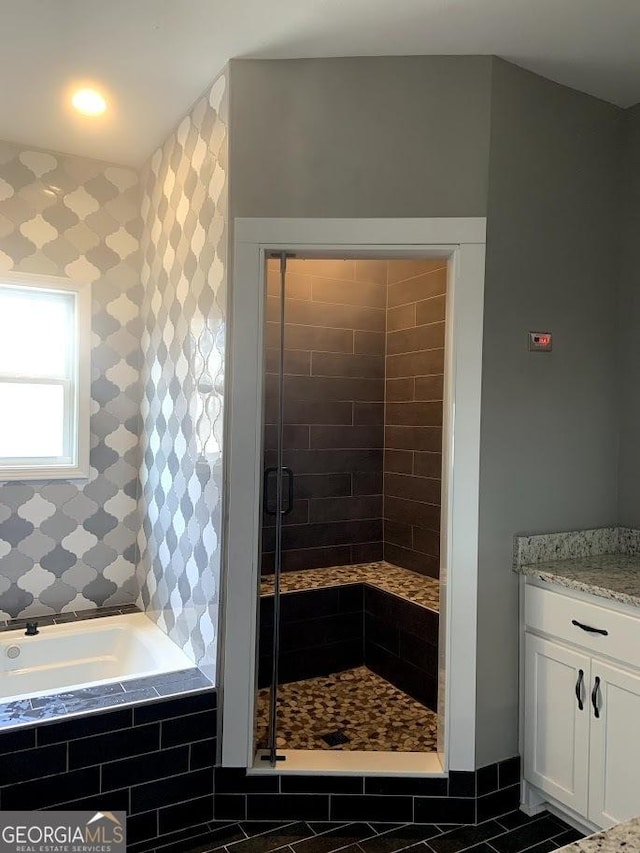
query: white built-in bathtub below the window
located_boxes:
[0,613,194,703]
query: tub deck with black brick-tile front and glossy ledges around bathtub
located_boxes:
[0,607,217,853]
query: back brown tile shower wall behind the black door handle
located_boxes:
[263,259,387,572]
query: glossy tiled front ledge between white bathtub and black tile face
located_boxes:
[0,667,213,732]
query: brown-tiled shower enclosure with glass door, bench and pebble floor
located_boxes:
[255,251,447,766]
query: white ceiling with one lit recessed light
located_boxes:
[0,0,640,166]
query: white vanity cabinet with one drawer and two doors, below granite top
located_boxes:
[521,581,640,828]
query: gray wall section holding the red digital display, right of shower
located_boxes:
[477,60,623,765]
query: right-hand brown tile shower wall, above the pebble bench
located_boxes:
[384,260,447,577]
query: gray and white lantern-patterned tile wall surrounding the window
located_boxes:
[0,142,142,619]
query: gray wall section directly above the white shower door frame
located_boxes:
[230,56,491,217]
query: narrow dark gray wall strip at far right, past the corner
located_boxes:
[618,104,640,527]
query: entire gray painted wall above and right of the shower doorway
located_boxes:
[230,57,640,766]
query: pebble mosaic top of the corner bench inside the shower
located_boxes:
[260,560,440,612]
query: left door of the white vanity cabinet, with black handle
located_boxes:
[524,633,591,814]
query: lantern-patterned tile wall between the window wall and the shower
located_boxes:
[138,74,227,678]
